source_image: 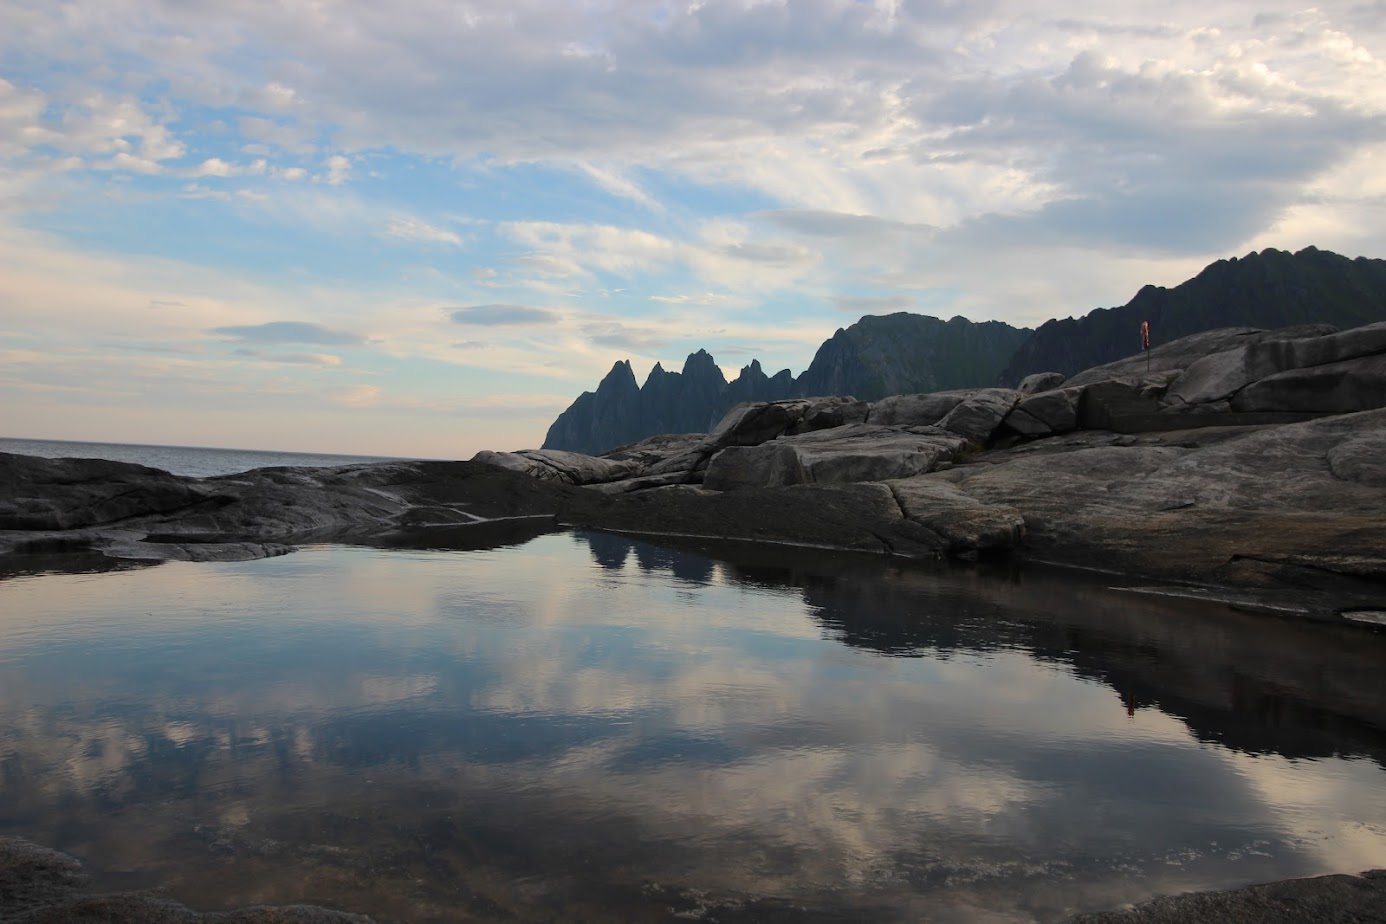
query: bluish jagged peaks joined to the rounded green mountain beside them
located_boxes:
[543,313,1030,453]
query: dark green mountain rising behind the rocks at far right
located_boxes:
[998,247,1386,385]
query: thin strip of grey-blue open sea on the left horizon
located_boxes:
[0,436,426,478]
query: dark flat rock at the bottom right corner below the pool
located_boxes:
[1070,870,1386,924]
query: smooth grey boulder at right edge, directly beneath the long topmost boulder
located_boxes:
[1232,351,1386,414]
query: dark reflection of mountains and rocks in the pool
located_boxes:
[581,533,1386,767]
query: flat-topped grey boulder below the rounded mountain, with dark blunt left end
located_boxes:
[703,424,965,490]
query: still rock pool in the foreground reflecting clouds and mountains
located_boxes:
[0,533,1386,921]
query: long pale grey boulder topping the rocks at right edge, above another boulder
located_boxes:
[1167,323,1386,410]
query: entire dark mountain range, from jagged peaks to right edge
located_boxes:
[543,247,1386,453]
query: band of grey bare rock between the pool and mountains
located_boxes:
[0,324,1386,625]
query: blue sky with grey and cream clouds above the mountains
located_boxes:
[0,0,1386,459]
